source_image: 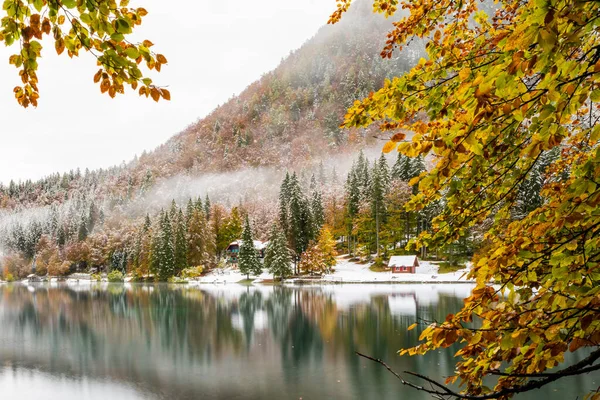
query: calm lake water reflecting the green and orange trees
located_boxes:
[0,284,600,400]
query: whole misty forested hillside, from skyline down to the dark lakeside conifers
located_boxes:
[0,2,422,275]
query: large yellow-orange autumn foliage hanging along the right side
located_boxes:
[330,0,600,399]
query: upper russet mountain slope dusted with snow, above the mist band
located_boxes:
[0,1,421,209]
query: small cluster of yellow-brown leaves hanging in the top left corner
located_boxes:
[0,0,171,107]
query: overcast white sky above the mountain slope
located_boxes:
[0,0,335,183]
